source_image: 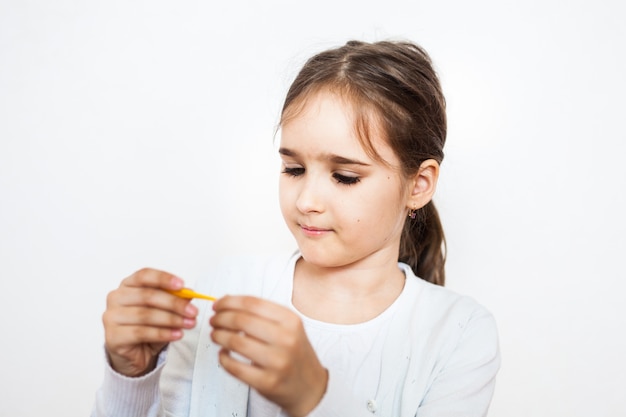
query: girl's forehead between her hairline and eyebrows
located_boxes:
[281,90,399,166]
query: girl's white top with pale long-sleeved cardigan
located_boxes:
[92,253,500,417]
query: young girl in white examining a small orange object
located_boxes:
[93,41,500,417]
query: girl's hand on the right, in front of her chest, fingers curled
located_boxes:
[210,296,328,417]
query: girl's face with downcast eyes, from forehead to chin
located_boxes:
[279,92,410,267]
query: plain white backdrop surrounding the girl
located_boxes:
[0,0,626,417]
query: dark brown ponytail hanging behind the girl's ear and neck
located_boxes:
[399,201,446,286]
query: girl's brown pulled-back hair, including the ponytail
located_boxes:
[280,41,446,285]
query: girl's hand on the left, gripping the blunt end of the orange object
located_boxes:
[102,269,198,377]
